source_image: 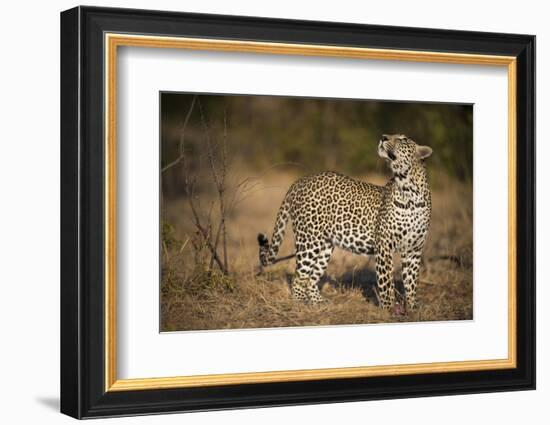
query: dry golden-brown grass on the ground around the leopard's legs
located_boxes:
[161,171,473,331]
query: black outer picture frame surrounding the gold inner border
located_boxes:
[61,7,535,418]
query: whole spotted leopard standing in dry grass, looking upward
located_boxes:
[257,134,432,312]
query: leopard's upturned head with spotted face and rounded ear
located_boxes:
[378,134,432,176]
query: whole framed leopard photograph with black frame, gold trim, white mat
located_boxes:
[61,7,535,418]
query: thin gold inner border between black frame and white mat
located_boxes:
[104,33,517,391]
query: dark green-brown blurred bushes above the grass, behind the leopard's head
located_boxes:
[161,93,473,196]
